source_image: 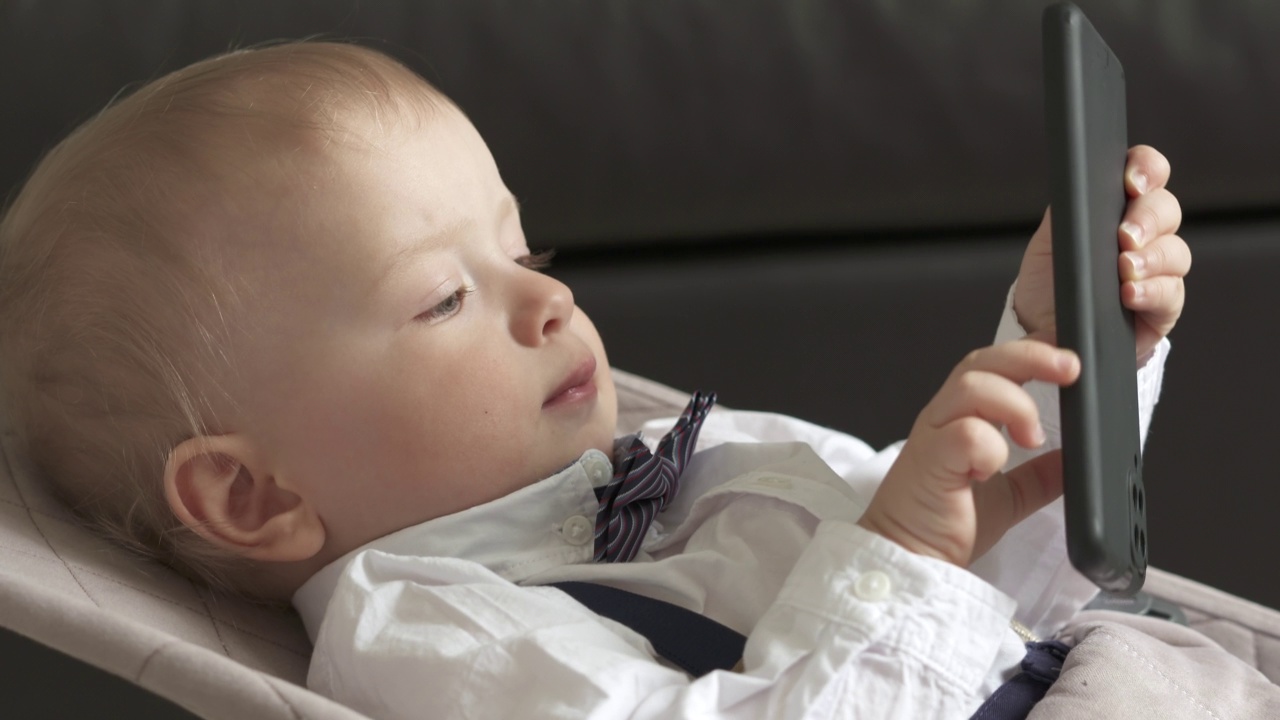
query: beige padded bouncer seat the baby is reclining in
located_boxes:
[0,372,1280,720]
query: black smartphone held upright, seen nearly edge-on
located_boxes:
[1042,3,1147,597]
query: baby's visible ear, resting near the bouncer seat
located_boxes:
[164,433,325,562]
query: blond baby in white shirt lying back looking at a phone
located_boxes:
[0,42,1190,717]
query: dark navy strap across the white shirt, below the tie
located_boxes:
[552,582,746,678]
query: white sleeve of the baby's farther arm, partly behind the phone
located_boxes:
[970,283,1170,637]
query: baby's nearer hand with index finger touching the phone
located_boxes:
[858,338,1080,568]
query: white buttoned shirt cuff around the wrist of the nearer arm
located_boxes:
[778,520,1015,692]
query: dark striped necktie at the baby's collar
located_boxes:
[595,392,716,562]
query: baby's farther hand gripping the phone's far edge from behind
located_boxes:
[1014,145,1192,359]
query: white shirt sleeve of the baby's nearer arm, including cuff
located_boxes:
[307,521,1014,720]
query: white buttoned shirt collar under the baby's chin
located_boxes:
[293,448,613,642]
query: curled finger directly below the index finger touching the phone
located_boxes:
[924,370,1044,447]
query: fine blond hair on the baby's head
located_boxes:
[0,42,448,594]
